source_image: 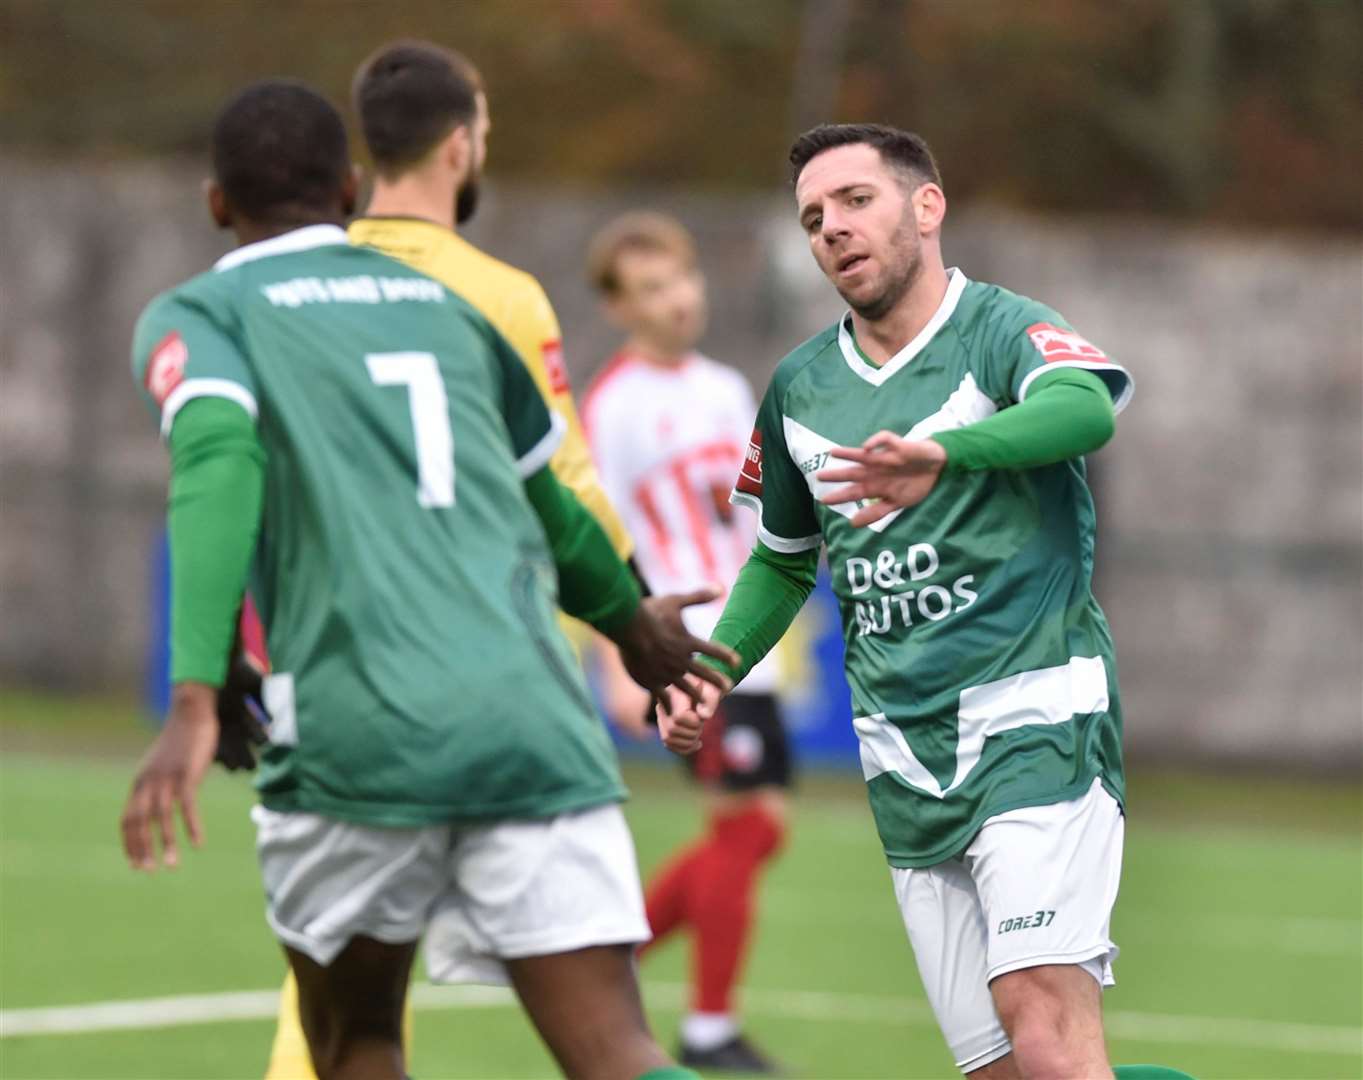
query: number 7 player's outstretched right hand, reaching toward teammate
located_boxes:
[616,585,739,702]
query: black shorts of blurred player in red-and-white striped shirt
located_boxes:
[686,693,795,795]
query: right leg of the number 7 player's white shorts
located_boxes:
[425,803,650,983]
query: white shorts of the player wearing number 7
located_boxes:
[251,805,649,985]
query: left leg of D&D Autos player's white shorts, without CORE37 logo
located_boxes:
[890,860,1011,1076]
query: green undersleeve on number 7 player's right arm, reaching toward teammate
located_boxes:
[525,466,639,638]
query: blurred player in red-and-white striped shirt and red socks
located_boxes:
[582,213,791,1073]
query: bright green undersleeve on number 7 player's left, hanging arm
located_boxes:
[168,397,264,686]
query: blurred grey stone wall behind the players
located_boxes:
[0,160,1363,769]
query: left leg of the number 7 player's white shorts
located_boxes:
[252,806,451,968]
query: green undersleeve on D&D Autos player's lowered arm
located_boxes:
[701,540,819,685]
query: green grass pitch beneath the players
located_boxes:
[0,694,1363,1080]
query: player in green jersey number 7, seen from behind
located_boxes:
[123,82,737,1080]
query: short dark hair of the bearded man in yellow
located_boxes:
[352,41,483,176]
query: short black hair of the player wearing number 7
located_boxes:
[213,79,350,221]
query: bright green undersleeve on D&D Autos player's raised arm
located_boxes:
[932,368,1116,472]
